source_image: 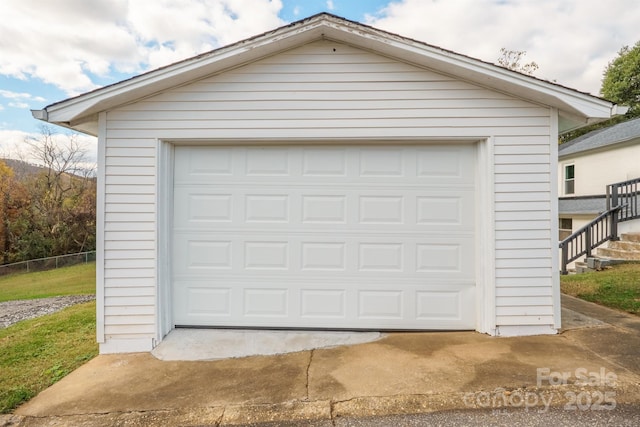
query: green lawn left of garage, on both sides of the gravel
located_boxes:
[0,263,98,413]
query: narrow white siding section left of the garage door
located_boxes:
[104,138,156,341]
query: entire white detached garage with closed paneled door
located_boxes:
[33,14,616,353]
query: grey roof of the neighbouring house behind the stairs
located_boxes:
[558,118,640,157]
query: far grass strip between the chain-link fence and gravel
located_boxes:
[0,262,96,302]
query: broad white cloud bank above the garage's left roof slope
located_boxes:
[0,0,283,95]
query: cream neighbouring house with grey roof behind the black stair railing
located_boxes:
[558,118,640,240]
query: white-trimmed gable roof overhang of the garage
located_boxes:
[32,13,625,135]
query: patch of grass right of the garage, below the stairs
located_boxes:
[560,264,640,315]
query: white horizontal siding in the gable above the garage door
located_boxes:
[108,42,549,139]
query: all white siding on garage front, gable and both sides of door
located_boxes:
[103,41,555,351]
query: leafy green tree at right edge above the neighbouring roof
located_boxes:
[600,41,640,119]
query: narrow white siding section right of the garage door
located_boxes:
[495,135,557,334]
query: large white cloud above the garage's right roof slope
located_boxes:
[366,0,640,94]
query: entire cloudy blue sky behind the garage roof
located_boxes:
[0,0,640,162]
